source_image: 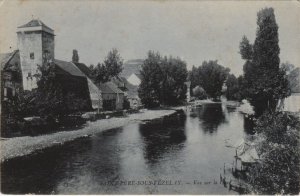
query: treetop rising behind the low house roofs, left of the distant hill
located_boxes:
[89,48,123,83]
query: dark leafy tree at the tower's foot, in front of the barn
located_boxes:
[34,62,90,118]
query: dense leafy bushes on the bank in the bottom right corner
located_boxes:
[250,112,300,194]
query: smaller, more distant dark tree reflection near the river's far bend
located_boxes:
[198,104,225,133]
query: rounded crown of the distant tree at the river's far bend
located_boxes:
[189,61,230,98]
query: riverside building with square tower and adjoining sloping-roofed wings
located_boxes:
[0,19,102,110]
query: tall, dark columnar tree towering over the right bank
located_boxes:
[240,8,290,115]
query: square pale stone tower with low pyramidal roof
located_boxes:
[17,20,55,90]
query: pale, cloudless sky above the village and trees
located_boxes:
[0,0,300,75]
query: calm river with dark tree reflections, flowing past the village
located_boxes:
[1,104,249,194]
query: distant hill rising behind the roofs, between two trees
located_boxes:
[120,59,144,79]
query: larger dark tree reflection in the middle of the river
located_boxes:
[140,112,186,163]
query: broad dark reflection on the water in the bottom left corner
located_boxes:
[1,139,91,194]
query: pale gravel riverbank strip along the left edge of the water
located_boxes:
[0,109,176,162]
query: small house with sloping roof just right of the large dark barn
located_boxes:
[99,82,124,111]
